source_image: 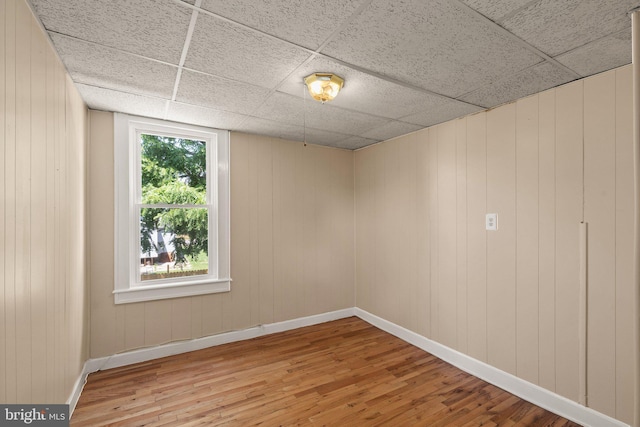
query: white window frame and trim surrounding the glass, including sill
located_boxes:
[113,113,231,304]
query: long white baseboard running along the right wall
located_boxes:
[354,308,629,427]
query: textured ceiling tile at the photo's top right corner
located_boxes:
[502,0,640,56]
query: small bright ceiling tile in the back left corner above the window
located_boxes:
[76,84,169,119]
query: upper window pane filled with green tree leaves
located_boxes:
[140,134,207,204]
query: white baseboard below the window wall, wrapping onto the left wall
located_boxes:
[67,308,355,416]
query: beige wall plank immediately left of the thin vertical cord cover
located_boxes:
[555,81,591,401]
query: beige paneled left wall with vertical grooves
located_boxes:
[0,0,88,403]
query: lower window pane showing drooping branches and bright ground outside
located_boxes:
[140,208,209,280]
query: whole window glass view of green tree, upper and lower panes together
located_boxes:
[140,134,209,280]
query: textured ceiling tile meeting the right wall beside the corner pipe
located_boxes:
[554,28,631,77]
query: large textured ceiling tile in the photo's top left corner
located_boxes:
[30,0,192,65]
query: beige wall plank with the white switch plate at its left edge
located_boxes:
[487,104,517,374]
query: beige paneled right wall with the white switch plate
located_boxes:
[355,67,633,422]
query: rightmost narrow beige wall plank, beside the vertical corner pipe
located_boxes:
[615,67,634,424]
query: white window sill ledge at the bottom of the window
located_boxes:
[113,279,231,304]
